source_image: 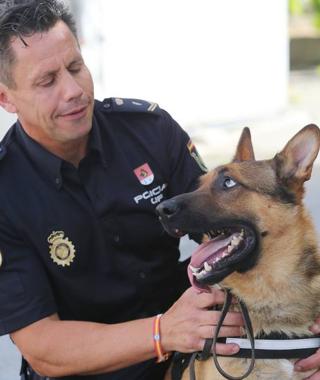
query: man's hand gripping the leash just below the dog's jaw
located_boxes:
[161,288,243,355]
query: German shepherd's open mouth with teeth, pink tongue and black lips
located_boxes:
[188,225,256,290]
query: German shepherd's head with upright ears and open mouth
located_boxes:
[157,125,320,290]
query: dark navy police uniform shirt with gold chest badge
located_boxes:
[0,98,203,380]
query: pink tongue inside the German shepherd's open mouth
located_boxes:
[188,236,231,292]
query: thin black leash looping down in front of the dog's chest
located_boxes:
[189,289,255,380]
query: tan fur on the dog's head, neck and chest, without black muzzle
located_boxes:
[166,125,320,380]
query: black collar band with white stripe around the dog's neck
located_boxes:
[226,336,320,359]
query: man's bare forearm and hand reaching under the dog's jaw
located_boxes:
[11,288,242,378]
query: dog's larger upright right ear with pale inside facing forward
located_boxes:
[275,124,320,182]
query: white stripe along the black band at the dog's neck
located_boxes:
[226,338,320,350]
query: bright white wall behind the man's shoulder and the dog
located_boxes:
[77,0,288,126]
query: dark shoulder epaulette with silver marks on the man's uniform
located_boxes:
[102,98,160,114]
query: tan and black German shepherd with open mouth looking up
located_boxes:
[158,125,320,380]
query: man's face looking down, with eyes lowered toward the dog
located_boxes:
[2,21,94,147]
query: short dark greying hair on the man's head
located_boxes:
[0,0,78,88]
